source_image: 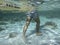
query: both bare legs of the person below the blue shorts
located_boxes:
[23,16,40,37]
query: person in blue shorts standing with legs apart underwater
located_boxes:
[23,0,43,37]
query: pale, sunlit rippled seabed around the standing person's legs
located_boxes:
[0,16,60,45]
